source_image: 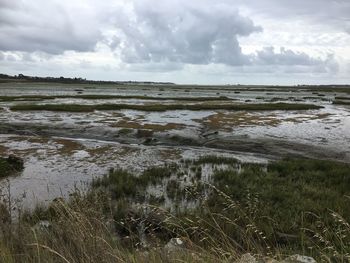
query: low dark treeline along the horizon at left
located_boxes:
[0,74,174,85]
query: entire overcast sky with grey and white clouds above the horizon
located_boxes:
[0,0,350,84]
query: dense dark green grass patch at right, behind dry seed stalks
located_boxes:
[209,159,350,252]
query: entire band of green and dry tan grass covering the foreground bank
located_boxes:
[0,156,350,262]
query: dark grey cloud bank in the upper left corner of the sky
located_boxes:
[0,0,100,54]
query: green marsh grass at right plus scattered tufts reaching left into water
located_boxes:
[89,159,350,258]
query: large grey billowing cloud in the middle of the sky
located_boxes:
[113,0,262,65]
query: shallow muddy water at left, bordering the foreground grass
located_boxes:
[0,135,267,211]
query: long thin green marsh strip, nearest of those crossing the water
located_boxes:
[10,103,322,112]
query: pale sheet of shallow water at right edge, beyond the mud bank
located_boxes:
[230,106,350,153]
